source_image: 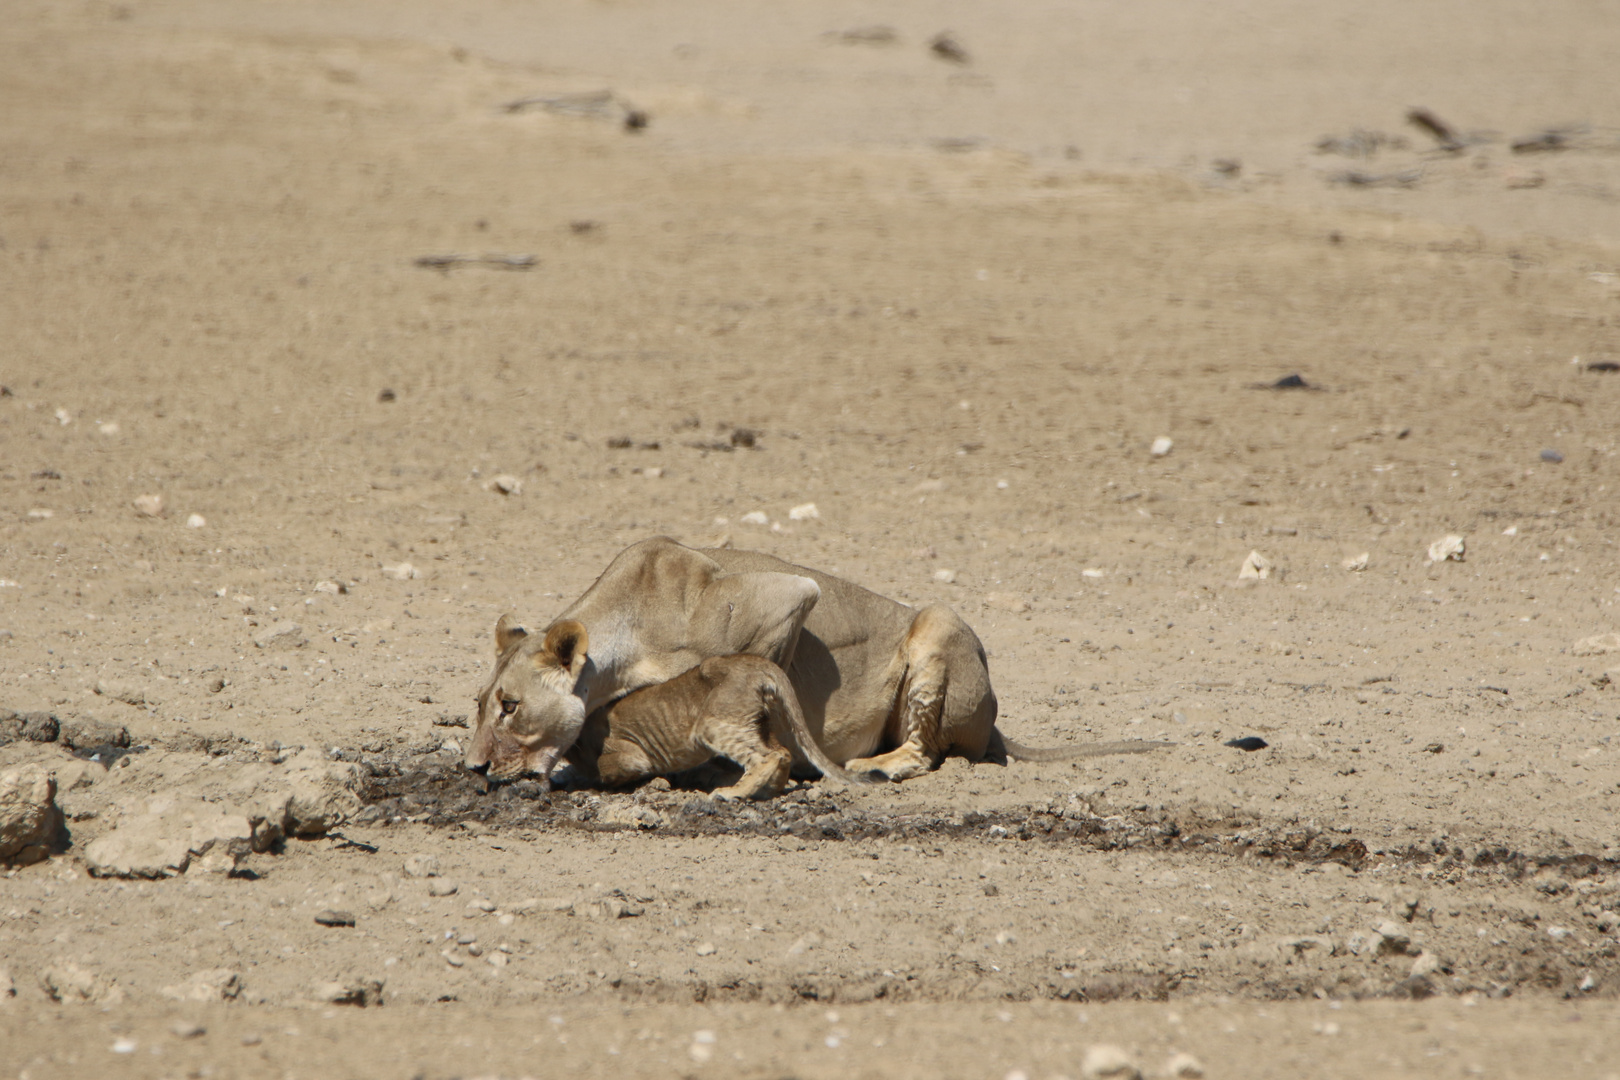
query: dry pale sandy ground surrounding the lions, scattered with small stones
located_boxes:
[0,2,1620,1078]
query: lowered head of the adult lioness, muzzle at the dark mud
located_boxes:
[467,615,590,782]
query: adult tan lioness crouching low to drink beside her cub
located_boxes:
[467,538,1158,782]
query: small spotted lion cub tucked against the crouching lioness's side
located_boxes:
[564,654,867,798]
